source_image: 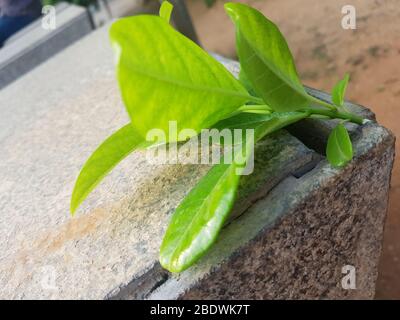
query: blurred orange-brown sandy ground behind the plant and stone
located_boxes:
[187,0,400,299]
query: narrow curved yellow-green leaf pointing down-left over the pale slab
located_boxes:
[71,124,146,214]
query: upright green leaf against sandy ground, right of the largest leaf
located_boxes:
[225,3,309,112]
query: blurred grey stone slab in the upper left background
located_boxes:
[0,3,92,89]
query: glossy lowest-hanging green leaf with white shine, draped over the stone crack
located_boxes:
[160,159,240,272]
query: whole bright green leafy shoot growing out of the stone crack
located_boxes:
[71,2,365,272]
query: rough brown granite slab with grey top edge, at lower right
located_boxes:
[148,124,394,299]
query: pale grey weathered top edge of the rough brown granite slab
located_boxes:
[147,123,395,299]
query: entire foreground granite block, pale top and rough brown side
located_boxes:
[0,27,394,299]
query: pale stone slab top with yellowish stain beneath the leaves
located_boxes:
[0,28,315,299]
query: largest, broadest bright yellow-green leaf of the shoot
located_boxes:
[110,15,252,142]
